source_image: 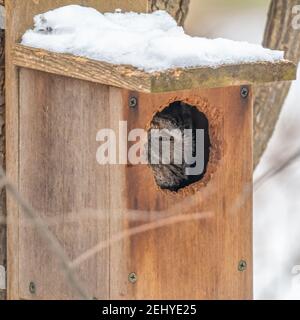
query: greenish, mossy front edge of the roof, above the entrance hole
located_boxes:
[151,61,296,92]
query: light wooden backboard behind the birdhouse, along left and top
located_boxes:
[5,0,148,299]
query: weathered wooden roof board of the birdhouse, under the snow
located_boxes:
[12,44,296,93]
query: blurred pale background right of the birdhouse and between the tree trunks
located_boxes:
[185,0,300,299]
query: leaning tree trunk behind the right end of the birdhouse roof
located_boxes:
[254,0,300,167]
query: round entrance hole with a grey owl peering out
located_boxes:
[148,101,211,192]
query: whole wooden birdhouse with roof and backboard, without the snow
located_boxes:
[6,0,296,300]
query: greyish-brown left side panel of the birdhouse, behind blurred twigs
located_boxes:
[18,69,109,299]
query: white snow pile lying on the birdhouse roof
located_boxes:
[22,5,283,72]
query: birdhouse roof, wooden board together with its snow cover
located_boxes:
[13,5,296,92]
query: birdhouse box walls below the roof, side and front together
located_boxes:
[18,68,252,299]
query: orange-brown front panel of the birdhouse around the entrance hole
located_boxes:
[110,87,252,299]
